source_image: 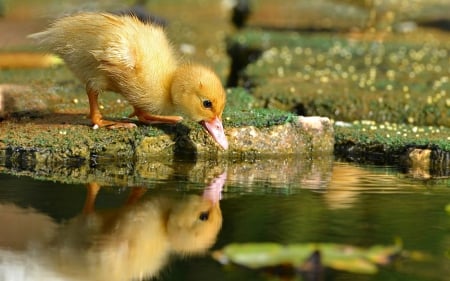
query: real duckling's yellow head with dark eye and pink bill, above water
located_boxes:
[171,64,228,149]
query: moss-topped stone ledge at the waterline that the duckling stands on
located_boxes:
[0,86,334,166]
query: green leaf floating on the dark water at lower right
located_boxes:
[213,243,401,274]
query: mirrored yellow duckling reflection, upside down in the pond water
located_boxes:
[0,171,226,280]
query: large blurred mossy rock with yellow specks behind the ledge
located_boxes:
[229,29,450,127]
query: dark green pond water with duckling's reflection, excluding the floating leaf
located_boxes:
[0,160,450,280]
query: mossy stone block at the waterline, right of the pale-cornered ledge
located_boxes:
[335,121,450,178]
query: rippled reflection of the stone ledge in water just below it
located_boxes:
[0,150,333,187]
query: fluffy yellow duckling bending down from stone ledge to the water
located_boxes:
[29,13,228,149]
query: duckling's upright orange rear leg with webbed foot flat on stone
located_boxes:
[86,82,136,129]
